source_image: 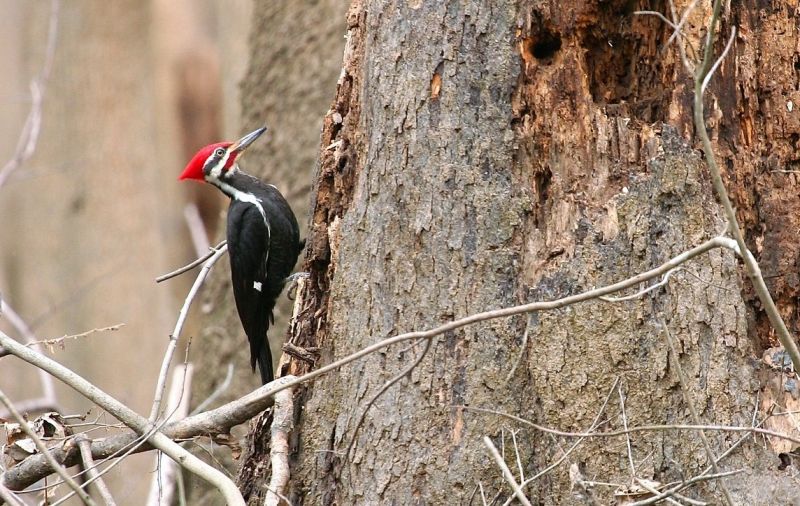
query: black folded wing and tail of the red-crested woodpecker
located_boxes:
[228,200,275,381]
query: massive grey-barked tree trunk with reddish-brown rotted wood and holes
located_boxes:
[240,0,800,504]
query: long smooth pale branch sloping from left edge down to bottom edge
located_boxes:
[0,332,245,506]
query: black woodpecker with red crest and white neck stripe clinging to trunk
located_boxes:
[179,127,303,384]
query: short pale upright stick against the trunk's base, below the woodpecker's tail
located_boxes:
[264,390,294,506]
